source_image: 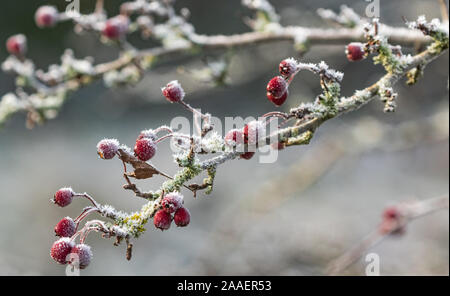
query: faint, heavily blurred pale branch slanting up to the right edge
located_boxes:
[194,102,449,273]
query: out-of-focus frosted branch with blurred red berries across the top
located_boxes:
[0,0,431,128]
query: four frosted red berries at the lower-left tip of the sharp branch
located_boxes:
[50,188,92,269]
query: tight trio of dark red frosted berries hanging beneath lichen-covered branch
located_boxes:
[153,192,191,230]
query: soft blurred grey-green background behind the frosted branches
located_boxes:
[0,0,449,275]
